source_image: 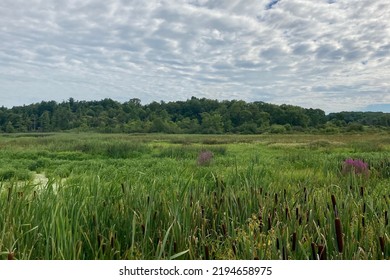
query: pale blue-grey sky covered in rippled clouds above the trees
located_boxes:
[0,0,390,112]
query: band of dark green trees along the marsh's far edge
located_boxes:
[0,97,390,134]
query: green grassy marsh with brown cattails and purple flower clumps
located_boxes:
[0,133,390,260]
